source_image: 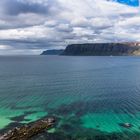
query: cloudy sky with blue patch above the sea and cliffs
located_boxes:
[0,0,140,55]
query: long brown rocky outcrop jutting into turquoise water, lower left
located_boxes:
[0,118,55,140]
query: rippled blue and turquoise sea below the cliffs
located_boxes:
[0,56,140,140]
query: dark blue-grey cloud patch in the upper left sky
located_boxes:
[0,0,58,16]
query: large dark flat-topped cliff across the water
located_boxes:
[63,43,140,56]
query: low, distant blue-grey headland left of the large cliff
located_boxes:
[41,49,64,55]
